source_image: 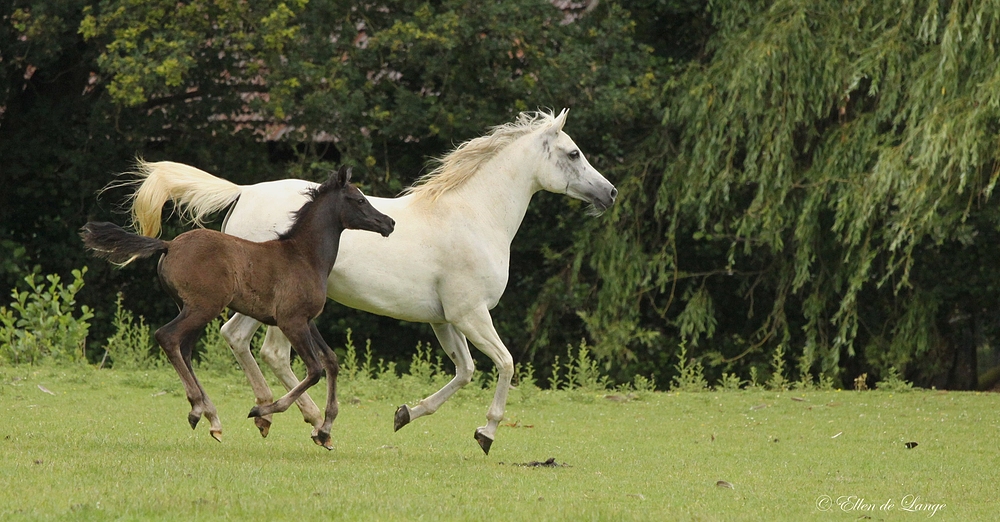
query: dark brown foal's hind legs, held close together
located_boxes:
[154,307,222,442]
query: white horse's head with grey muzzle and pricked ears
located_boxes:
[537,109,618,212]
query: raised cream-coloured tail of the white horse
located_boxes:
[108,160,243,237]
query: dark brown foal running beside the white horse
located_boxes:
[80,167,395,449]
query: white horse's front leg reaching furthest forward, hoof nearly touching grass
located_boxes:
[454,307,514,455]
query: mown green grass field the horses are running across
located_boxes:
[0,367,1000,521]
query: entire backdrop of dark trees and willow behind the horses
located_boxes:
[0,0,1000,388]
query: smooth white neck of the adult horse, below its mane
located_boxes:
[441,142,540,245]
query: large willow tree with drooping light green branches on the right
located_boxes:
[579,0,1000,388]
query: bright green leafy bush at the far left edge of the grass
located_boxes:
[0,267,94,364]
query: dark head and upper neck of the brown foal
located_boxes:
[279,167,396,239]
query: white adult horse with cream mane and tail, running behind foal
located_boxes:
[132,110,618,454]
